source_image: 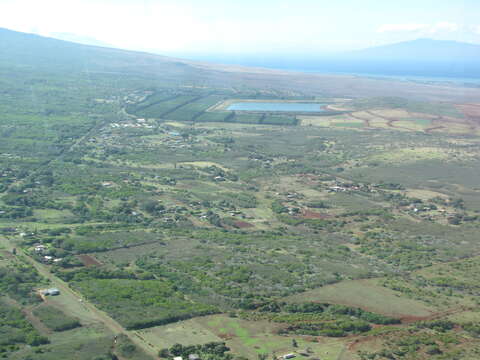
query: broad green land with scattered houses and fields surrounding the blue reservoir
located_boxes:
[0,26,480,360]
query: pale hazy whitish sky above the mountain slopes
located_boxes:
[0,0,480,54]
